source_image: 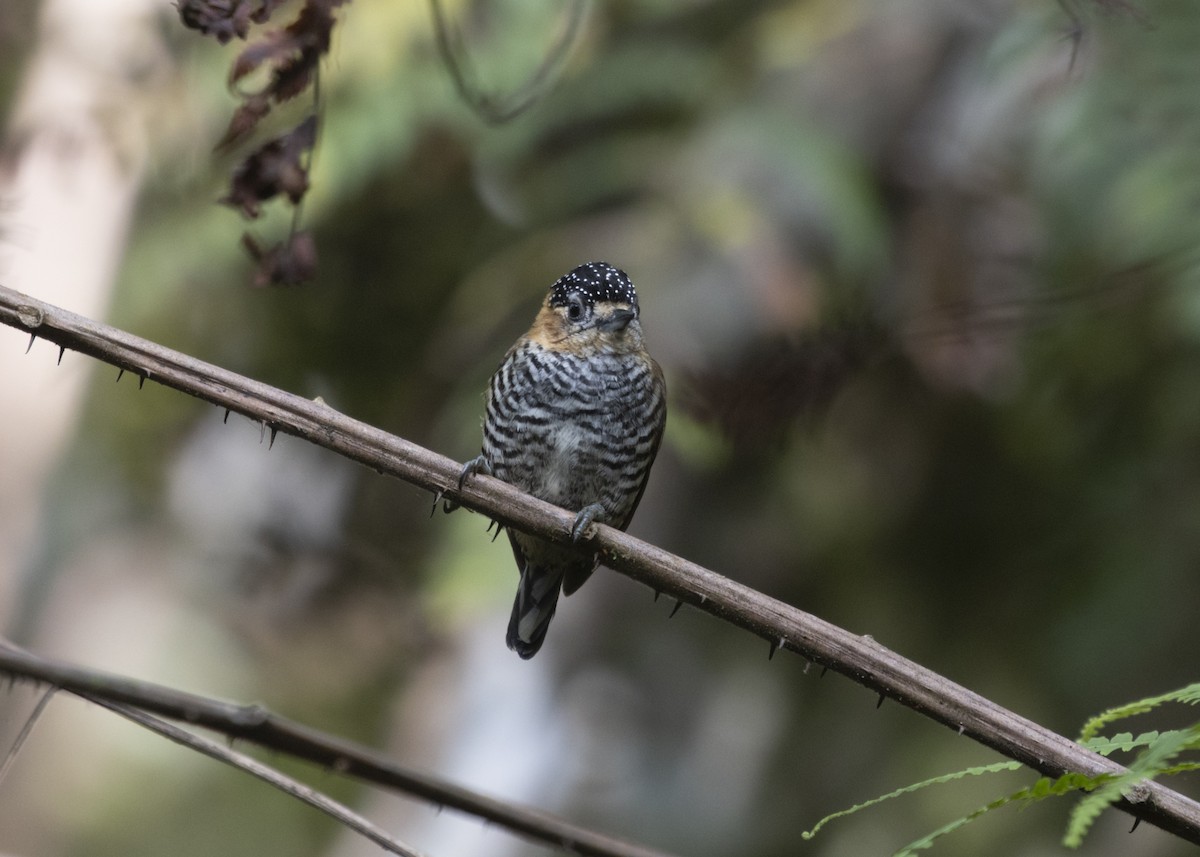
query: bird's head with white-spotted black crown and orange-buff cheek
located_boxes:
[529,262,642,354]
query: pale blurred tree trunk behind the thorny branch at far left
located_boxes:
[0,0,168,631]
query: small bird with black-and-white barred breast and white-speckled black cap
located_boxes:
[458,262,667,659]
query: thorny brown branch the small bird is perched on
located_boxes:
[7,287,1200,845]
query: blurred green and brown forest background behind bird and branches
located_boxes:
[0,0,1200,857]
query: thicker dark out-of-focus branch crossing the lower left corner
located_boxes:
[0,641,665,857]
